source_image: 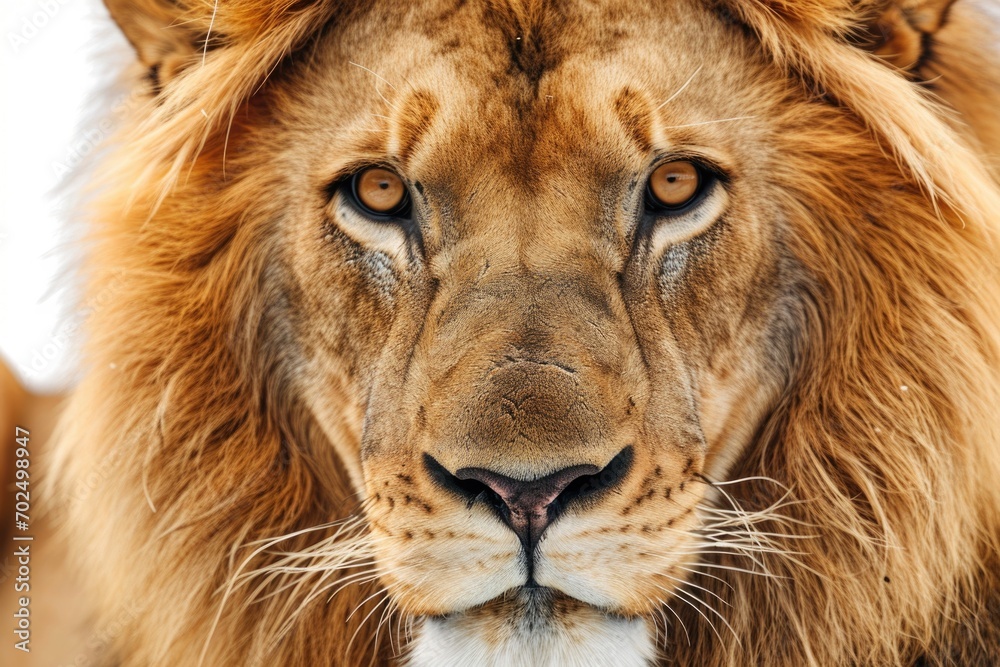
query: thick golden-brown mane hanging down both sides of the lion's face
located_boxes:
[55,0,1000,665]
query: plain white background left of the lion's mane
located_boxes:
[0,0,130,391]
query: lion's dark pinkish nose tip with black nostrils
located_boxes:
[424,447,632,555]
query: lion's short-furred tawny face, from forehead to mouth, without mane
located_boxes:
[276,3,793,656]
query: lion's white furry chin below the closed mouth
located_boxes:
[406,588,656,667]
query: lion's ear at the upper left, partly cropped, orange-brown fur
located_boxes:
[104,0,207,88]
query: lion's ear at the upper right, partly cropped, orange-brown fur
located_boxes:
[867,0,955,69]
